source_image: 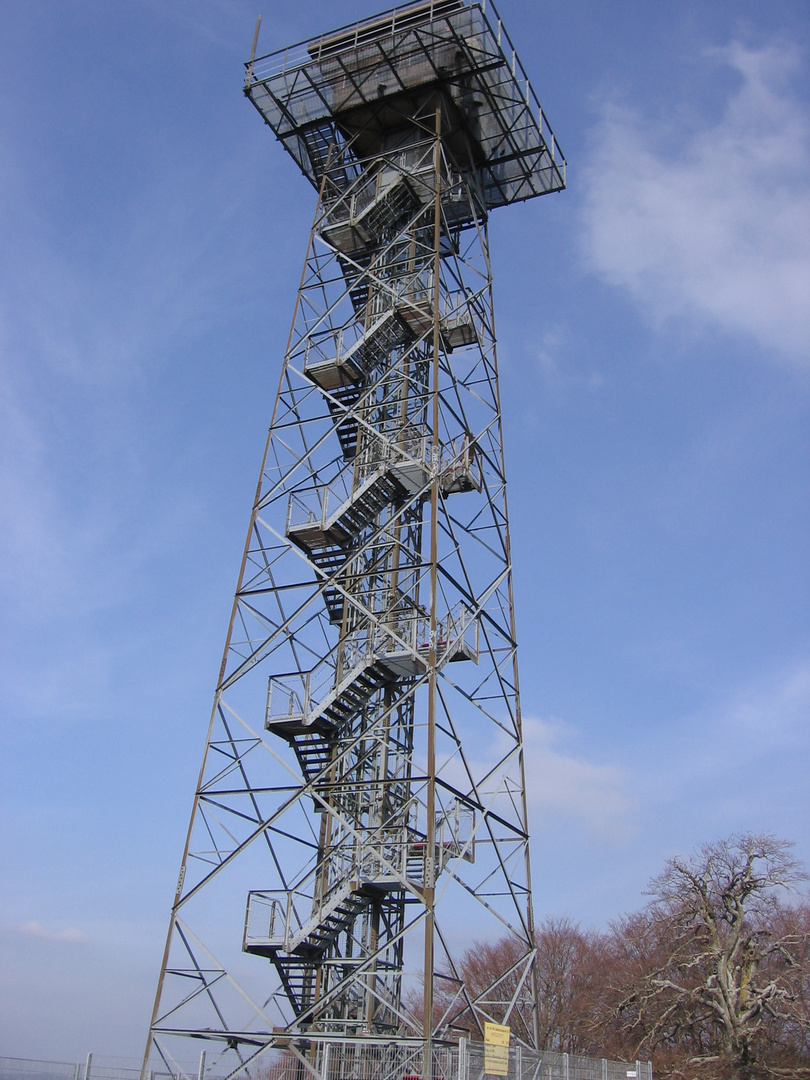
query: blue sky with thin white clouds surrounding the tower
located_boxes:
[0,0,810,1061]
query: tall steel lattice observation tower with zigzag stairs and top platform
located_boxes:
[145,0,565,1077]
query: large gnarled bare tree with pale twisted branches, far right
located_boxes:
[615,834,807,1080]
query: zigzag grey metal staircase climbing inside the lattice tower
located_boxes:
[250,63,481,1041]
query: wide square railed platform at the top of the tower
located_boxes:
[245,0,565,210]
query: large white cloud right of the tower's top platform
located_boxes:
[582,42,810,364]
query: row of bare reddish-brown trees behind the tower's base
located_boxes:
[436,834,810,1080]
